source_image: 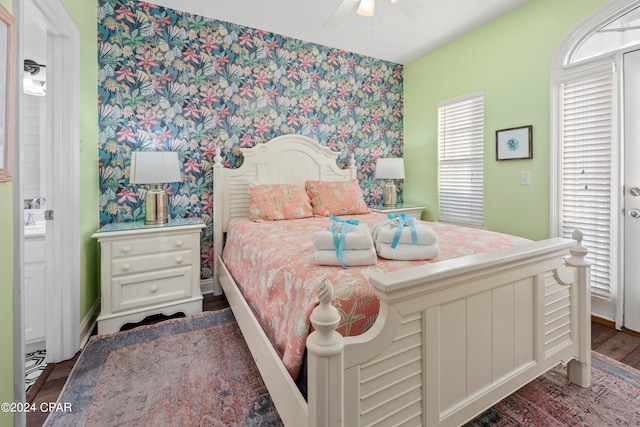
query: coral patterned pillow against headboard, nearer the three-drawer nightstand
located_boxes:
[249,184,313,221]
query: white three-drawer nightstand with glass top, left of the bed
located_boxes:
[91,218,204,334]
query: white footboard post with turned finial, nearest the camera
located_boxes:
[307,279,344,427]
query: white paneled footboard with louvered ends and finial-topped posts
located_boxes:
[308,239,591,426]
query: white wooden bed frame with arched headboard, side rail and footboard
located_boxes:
[214,135,591,427]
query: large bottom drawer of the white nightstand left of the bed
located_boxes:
[111,267,193,313]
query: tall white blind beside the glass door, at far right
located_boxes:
[561,70,615,299]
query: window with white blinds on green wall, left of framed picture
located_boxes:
[438,94,484,227]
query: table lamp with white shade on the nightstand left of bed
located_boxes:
[129,151,182,224]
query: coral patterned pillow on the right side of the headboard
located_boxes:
[304,179,369,216]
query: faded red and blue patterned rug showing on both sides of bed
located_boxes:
[45,309,640,427]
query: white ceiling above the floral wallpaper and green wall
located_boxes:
[148,0,529,64]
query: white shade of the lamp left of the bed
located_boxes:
[129,151,182,184]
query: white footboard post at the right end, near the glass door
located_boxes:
[566,230,591,387]
